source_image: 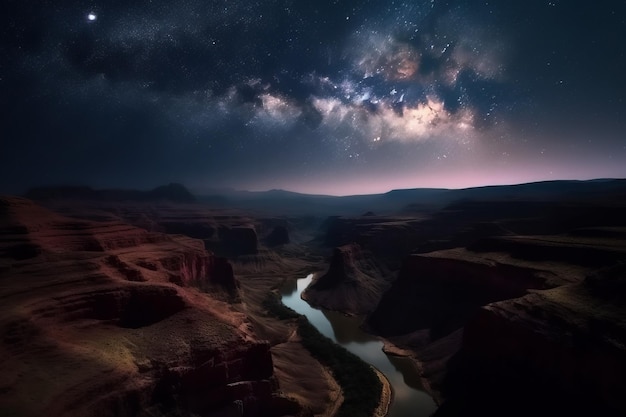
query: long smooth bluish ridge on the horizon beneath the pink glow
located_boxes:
[198,179,626,216]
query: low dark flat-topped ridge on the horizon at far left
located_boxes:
[24,183,196,203]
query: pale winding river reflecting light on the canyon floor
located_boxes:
[281,274,437,417]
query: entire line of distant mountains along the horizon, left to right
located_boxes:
[26,179,626,216]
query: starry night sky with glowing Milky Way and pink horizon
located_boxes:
[0,0,626,195]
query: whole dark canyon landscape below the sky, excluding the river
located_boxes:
[0,180,626,417]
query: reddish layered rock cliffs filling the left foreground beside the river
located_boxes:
[0,198,299,417]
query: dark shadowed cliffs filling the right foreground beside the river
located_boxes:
[367,227,626,416]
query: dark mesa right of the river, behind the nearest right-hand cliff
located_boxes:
[367,249,561,339]
